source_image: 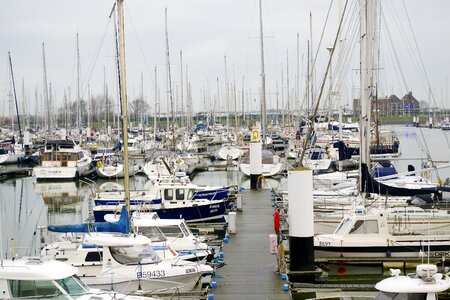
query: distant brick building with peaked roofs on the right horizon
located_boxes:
[353,92,420,116]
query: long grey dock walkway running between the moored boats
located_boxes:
[211,190,291,300]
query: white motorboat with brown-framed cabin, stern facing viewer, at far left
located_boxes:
[33,140,93,180]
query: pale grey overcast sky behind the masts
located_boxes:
[0,0,450,114]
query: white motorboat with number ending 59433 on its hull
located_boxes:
[41,233,213,293]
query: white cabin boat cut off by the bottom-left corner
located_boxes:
[0,258,154,300]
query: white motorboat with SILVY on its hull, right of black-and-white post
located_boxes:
[314,210,450,258]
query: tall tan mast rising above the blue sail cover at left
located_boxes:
[117,0,130,213]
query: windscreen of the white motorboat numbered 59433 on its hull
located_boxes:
[109,245,160,264]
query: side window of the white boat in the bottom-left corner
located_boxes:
[8,280,62,298]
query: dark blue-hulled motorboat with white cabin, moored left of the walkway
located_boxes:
[93,176,237,222]
